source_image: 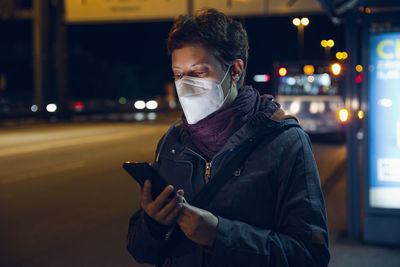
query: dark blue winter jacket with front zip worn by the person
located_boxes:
[127,110,330,267]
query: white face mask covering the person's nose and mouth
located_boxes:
[175,66,232,124]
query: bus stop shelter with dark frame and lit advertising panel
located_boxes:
[320,0,400,244]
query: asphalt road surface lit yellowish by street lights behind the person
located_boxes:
[0,120,346,267]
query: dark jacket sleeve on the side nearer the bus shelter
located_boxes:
[211,129,330,267]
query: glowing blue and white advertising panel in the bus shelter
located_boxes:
[368,32,400,209]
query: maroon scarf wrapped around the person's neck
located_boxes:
[182,86,280,159]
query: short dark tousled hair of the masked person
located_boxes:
[167,9,249,86]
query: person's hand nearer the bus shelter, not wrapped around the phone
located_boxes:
[177,201,218,246]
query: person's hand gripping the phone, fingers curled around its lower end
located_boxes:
[139,180,183,225]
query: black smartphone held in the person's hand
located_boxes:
[122,161,176,199]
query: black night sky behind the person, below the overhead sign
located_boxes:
[0,15,344,103]
